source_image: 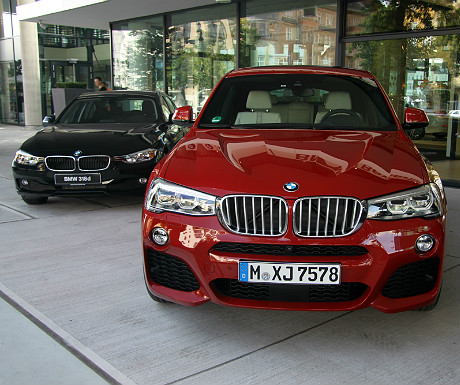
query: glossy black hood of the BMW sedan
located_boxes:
[21,123,163,157]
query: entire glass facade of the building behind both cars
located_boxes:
[108,0,460,184]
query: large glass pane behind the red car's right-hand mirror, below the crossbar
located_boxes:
[346,35,460,180]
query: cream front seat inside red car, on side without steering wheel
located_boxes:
[235,90,281,125]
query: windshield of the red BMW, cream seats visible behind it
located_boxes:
[199,74,397,131]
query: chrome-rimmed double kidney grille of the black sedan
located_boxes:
[45,155,110,171]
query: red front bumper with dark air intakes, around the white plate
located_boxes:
[143,209,445,313]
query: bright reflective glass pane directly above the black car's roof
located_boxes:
[112,17,164,90]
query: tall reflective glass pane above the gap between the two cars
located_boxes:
[166,4,237,112]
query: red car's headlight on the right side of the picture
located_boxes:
[367,183,444,220]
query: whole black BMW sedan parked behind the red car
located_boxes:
[13,91,189,204]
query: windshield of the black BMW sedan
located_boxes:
[57,96,158,124]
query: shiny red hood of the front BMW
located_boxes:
[164,129,424,199]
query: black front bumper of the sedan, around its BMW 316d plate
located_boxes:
[13,160,155,197]
